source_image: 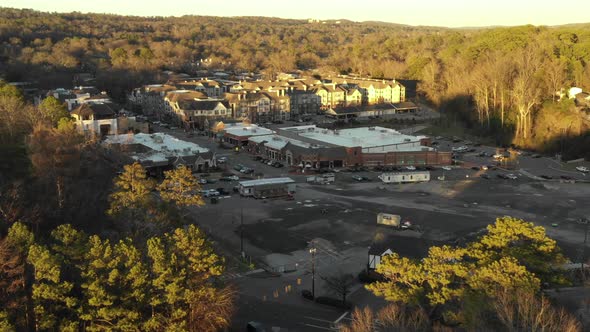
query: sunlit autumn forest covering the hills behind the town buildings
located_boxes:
[0,8,590,158]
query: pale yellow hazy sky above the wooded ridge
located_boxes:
[0,0,590,27]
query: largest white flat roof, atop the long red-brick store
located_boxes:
[283,125,426,150]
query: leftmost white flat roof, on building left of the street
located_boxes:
[105,133,209,162]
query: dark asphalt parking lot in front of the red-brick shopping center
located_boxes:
[147,122,590,331]
